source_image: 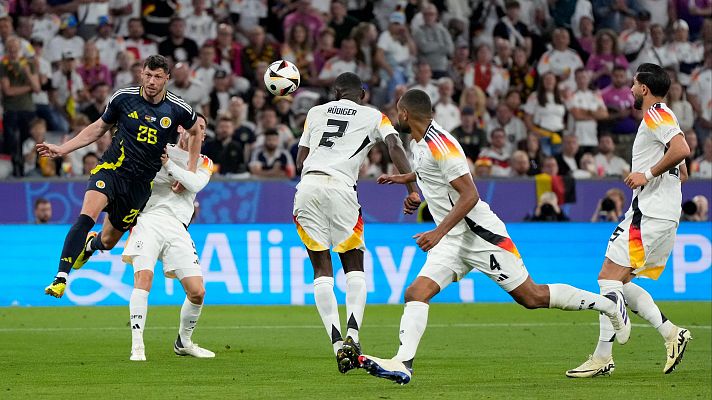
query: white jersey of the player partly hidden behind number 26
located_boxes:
[141,144,213,226]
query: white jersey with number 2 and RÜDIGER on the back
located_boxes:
[299,99,398,186]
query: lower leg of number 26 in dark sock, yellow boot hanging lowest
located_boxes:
[45,190,109,298]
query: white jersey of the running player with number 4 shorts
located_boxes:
[410,121,506,235]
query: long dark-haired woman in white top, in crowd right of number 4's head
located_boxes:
[524,72,564,154]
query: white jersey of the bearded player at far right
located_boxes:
[631,103,684,221]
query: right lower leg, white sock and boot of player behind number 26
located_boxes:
[173,276,215,358]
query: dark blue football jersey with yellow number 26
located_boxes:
[98,86,197,181]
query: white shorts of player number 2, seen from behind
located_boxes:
[293,174,366,253]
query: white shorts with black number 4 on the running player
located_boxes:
[418,216,529,292]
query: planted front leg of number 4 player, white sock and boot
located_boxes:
[359,276,440,385]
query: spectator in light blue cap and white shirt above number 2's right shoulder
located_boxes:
[377,12,417,98]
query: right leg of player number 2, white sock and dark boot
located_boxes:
[339,249,367,368]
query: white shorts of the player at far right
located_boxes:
[606,207,678,279]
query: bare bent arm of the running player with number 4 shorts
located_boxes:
[413,173,480,251]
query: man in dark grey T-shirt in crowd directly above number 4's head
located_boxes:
[413,3,455,79]
